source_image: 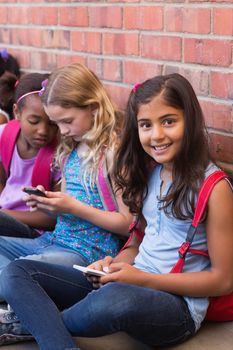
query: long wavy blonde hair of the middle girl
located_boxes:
[42,63,122,189]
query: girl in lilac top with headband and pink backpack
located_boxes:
[0,73,61,238]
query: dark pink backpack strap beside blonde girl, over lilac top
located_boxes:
[32,139,57,191]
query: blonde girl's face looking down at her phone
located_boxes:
[45,105,93,141]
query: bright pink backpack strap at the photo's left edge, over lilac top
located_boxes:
[0,119,20,177]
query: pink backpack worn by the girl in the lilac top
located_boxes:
[0,119,57,190]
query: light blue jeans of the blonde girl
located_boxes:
[0,233,89,300]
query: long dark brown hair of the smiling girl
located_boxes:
[114,74,210,219]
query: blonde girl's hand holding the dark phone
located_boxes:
[24,190,78,214]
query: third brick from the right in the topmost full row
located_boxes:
[123,6,163,30]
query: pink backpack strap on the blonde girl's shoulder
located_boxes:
[97,157,118,211]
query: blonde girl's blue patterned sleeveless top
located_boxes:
[46,150,121,263]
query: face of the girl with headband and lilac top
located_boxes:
[14,95,58,149]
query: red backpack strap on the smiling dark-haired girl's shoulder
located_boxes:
[170,170,227,273]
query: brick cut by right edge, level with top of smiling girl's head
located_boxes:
[211,72,233,99]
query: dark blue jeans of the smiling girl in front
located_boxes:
[1,260,195,350]
